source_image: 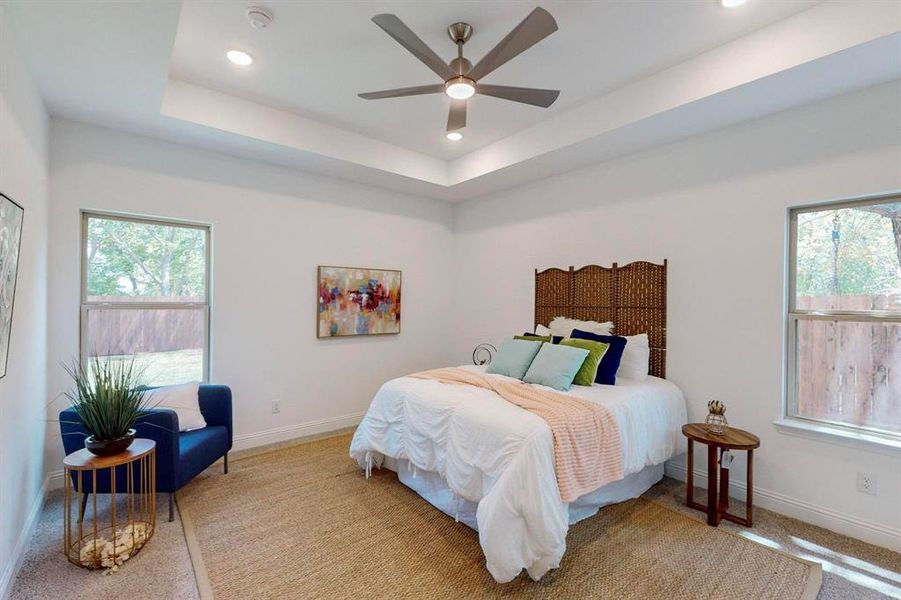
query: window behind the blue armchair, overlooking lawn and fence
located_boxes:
[81,213,210,385]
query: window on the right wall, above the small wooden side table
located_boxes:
[786,196,901,440]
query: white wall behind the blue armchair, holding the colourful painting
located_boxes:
[48,119,453,466]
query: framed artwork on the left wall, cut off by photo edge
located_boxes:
[0,194,25,377]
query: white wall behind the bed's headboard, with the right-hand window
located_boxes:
[454,83,901,546]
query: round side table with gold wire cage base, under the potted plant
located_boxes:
[63,438,156,569]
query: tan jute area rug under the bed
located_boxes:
[178,435,821,600]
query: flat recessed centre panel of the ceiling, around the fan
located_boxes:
[170,0,816,159]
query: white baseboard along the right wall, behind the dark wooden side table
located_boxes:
[665,461,901,552]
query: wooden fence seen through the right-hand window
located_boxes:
[797,296,901,431]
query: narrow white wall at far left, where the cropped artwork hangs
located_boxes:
[0,7,47,597]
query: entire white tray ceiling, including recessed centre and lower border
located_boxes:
[0,0,901,200]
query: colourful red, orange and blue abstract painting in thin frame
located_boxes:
[316,267,400,338]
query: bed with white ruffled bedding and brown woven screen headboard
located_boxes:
[350,262,686,582]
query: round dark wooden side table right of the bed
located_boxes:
[682,423,760,527]
